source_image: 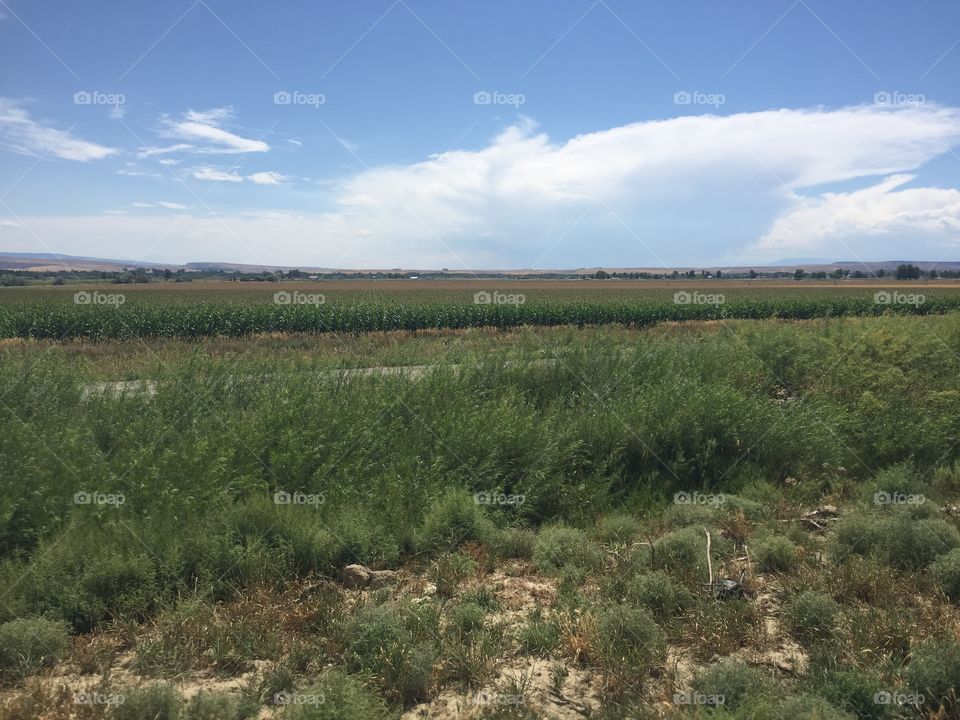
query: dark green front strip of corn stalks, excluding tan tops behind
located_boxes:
[0,296,960,339]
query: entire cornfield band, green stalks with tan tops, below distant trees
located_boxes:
[0,282,960,339]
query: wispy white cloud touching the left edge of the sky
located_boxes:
[0,97,119,162]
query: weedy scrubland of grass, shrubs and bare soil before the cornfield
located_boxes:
[0,286,960,720]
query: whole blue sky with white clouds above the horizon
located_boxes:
[0,0,960,270]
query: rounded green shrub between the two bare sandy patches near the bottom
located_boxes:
[597,605,666,678]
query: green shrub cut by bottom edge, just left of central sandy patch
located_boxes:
[281,670,396,720]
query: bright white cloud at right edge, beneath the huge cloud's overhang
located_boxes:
[759,175,960,252]
